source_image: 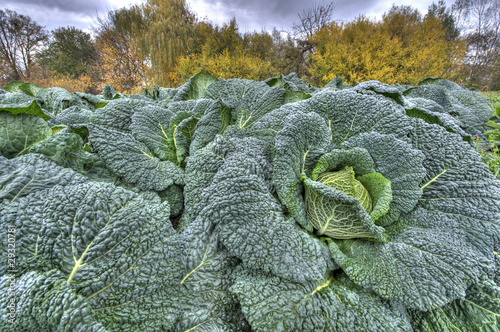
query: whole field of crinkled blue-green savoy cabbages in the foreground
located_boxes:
[0,73,500,332]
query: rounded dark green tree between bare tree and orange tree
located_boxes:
[37,27,97,78]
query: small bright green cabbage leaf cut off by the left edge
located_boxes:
[0,112,52,158]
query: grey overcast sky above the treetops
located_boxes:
[0,0,454,32]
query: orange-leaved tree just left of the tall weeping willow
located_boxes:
[93,9,148,93]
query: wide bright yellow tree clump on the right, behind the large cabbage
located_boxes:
[310,6,465,85]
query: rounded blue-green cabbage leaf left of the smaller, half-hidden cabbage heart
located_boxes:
[89,99,183,191]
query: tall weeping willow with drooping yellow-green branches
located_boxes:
[117,0,195,86]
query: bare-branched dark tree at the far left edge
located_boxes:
[0,9,48,80]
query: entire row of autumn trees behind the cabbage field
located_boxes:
[0,0,500,93]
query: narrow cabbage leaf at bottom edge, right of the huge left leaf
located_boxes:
[176,218,249,331]
